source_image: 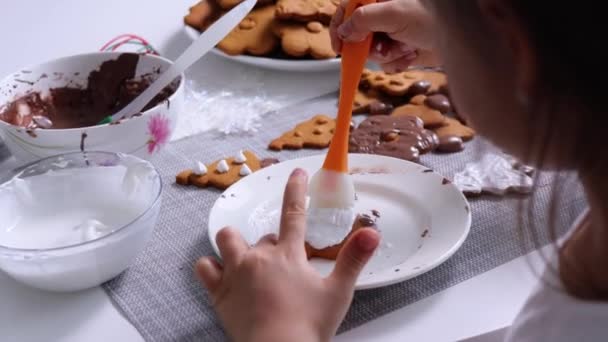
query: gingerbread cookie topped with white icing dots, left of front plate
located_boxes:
[175,151,261,190]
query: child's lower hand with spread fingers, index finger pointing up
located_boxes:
[196,169,380,342]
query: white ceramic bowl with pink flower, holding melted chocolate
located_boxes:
[0,52,184,164]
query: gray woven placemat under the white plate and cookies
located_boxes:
[103,94,585,341]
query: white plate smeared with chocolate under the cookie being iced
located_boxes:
[209,154,471,289]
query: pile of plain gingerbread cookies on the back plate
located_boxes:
[184,0,339,59]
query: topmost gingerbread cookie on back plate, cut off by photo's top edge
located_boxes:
[276,0,340,25]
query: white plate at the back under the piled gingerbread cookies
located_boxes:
[184,25,340,72]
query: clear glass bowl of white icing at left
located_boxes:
[0,152,162,292]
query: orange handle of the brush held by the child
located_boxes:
[323,0,376,172]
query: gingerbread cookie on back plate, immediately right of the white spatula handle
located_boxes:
[217,5,279,56]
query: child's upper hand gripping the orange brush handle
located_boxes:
[329,0,438,72]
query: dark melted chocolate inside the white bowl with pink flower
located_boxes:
[0,53,179,131]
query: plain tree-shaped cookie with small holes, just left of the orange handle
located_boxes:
[268,115,336,151]
